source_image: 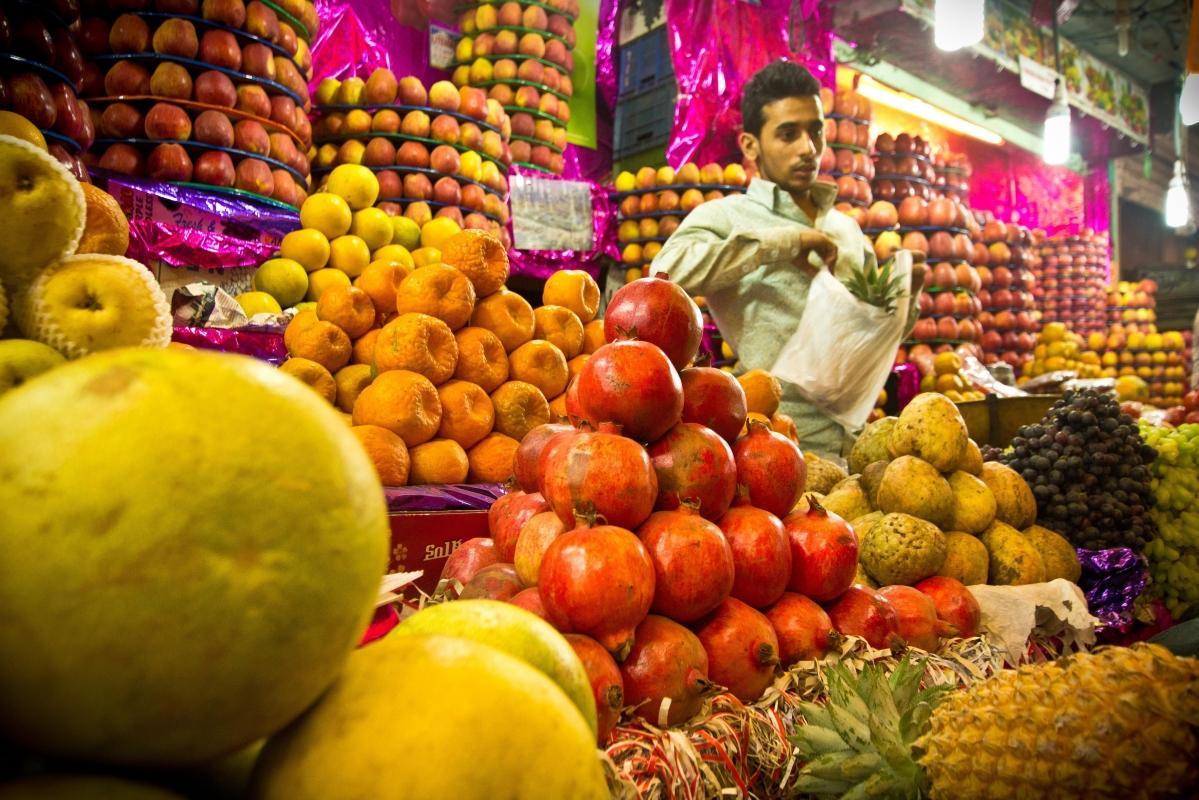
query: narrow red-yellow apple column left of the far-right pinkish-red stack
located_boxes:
[975,219,1040,373]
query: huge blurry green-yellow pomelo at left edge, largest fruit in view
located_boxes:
[0,349,388,765]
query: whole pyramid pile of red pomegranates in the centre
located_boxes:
[442,276,977,742]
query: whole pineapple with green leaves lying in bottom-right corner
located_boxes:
[791,644,1199,800]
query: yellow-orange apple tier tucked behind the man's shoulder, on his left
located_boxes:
[610,163,748,281]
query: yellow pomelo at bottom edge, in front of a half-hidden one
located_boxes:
[251,636,608,800]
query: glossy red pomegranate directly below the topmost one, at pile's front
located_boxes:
[578,339,682,441]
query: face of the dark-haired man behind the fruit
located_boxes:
[741,95,825,194]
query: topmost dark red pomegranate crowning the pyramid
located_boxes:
[603,272,704,369]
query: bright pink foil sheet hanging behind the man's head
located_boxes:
[665,0,835,168]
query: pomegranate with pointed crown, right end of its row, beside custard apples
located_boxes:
[783,497,857,602]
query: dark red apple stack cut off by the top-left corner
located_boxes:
[0,2,96,180]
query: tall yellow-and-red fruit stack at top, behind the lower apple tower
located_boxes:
[453,0,579,175]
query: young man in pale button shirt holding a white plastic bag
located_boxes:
[653,61,923,456]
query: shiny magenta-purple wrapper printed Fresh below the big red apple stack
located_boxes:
[94,173,300,270]
